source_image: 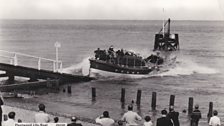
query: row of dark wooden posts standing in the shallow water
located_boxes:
[64,85,213,120]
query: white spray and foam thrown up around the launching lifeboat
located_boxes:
[62,56,218,79]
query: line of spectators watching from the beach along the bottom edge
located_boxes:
[0,96,221,126]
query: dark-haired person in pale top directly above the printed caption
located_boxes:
[34,104,50,123]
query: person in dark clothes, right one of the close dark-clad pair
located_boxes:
[168,105,180,126]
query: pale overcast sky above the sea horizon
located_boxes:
[0,0,224,20]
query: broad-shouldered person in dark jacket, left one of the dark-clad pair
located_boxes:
[156,109,173,126]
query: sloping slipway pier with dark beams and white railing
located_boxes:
[0,50,93,91]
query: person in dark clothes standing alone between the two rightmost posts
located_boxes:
[191,104,201,126]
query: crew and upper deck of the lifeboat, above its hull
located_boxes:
[94,46,164,66]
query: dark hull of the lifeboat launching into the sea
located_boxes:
[89,59,152,75]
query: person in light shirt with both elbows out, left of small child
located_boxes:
[121,105,142,126]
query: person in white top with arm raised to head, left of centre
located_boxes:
[96,111,114,126]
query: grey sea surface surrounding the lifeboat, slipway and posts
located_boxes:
[0,20,224,125]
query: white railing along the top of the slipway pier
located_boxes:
[0,50,62,73]
